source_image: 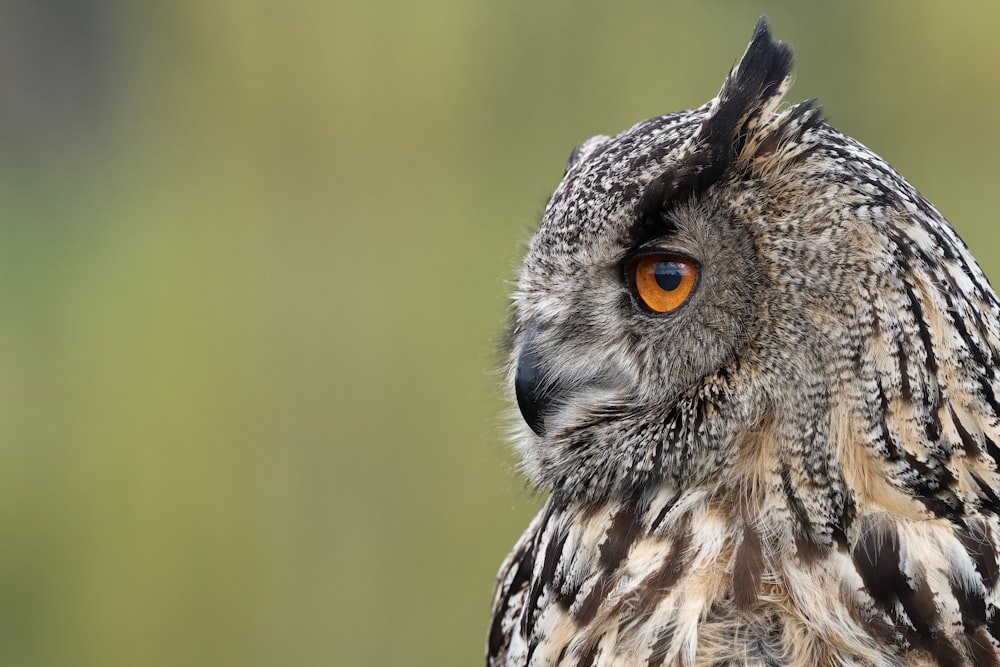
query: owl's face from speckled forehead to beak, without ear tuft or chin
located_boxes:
[515,118,761,439]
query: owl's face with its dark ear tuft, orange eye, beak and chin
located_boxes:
[510,28,819,495]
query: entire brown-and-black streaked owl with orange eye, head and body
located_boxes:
[487,19,1000,667]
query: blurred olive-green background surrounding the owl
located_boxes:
[0,0,1000,666]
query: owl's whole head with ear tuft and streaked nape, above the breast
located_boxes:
[507,19,1000,542]
